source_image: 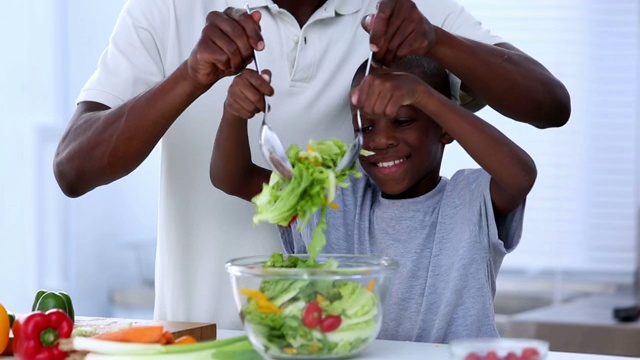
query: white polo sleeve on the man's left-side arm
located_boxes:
[76,0,169,107]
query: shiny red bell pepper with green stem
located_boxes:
[13,309,73,360]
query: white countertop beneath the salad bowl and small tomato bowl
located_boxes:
[218,329,631,360]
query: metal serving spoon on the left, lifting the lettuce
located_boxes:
[244,4,293,179]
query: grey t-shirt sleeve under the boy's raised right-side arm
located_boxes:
[450,169,526,255]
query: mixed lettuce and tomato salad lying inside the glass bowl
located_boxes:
[240,253,380,356]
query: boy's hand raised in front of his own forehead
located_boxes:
[351,71,428,117]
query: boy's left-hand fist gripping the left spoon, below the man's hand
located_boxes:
[224,69,273,119]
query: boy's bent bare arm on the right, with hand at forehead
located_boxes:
[351,71,537,215]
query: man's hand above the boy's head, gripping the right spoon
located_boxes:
[362,0,436,64]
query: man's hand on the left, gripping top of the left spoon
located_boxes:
[187,8,264,89]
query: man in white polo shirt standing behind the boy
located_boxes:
[54,0,570,328]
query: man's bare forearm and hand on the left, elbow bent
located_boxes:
[54,8,264,197]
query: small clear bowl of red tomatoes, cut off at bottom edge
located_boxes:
[449,338,549,360]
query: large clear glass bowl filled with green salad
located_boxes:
[226,253,398,359]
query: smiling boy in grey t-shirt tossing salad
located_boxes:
[210,57,536,343]
